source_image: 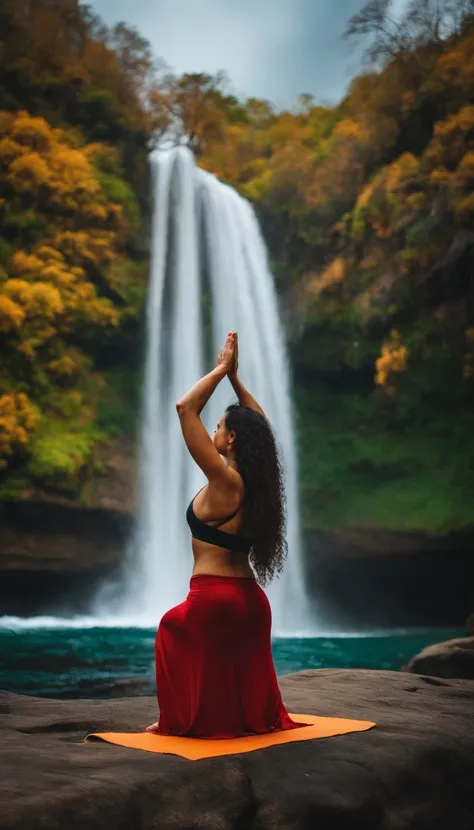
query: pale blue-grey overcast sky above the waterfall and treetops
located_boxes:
[92,0,405,107]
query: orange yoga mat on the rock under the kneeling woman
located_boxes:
[84,714,375,761]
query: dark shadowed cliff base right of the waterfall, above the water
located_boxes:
[303,528,474,629]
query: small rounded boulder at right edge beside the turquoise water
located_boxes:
[404,637,474,680]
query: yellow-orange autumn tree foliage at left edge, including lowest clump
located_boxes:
[0,112,126,466]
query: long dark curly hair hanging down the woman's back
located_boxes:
[225,404,288,585]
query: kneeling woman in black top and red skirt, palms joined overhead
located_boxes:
[147,332,303,738]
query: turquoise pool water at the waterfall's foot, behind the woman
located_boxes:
[0,619,464,698]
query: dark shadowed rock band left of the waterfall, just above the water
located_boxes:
[0,501,133,615]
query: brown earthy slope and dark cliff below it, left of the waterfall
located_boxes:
[0,439,138,614]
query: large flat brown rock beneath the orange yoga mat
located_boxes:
[0,669,474,830]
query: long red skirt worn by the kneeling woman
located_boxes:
[155,574,303,738]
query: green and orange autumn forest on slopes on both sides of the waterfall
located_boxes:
[0,0,474,534]
